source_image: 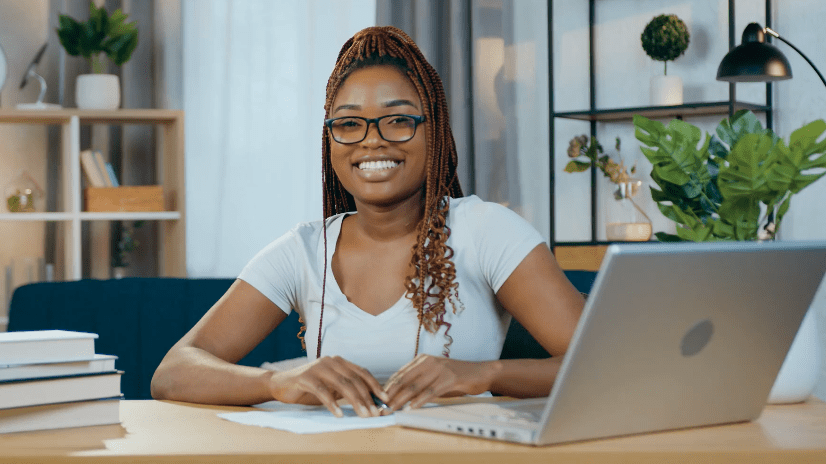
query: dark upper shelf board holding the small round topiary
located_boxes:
[553,101,770,121]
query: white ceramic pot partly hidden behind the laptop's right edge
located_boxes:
[768,306,821,404]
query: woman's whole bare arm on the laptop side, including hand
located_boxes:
[385,244,585,410]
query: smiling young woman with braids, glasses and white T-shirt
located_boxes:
[152,27,584,417]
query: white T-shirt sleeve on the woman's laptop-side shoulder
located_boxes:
[466,200,545,292]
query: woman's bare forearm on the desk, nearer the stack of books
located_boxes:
[151,346,273,405]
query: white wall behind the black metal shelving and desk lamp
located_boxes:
[553,0,826,398]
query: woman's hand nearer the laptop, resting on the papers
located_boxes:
[384,354,497,411]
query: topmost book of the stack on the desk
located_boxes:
[0,330,98,365]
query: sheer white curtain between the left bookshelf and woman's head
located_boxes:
[182,0,376,277]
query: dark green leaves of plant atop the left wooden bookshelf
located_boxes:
[57,1,138,73]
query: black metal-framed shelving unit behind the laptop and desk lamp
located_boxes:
[548,0,773,270]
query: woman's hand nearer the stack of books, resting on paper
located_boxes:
[270,356,389,417]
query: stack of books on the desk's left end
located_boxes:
[0,330,123,433]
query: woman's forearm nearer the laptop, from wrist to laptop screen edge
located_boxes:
[487,356,562,398]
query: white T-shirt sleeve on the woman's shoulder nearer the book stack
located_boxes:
[238,229,299,314]
